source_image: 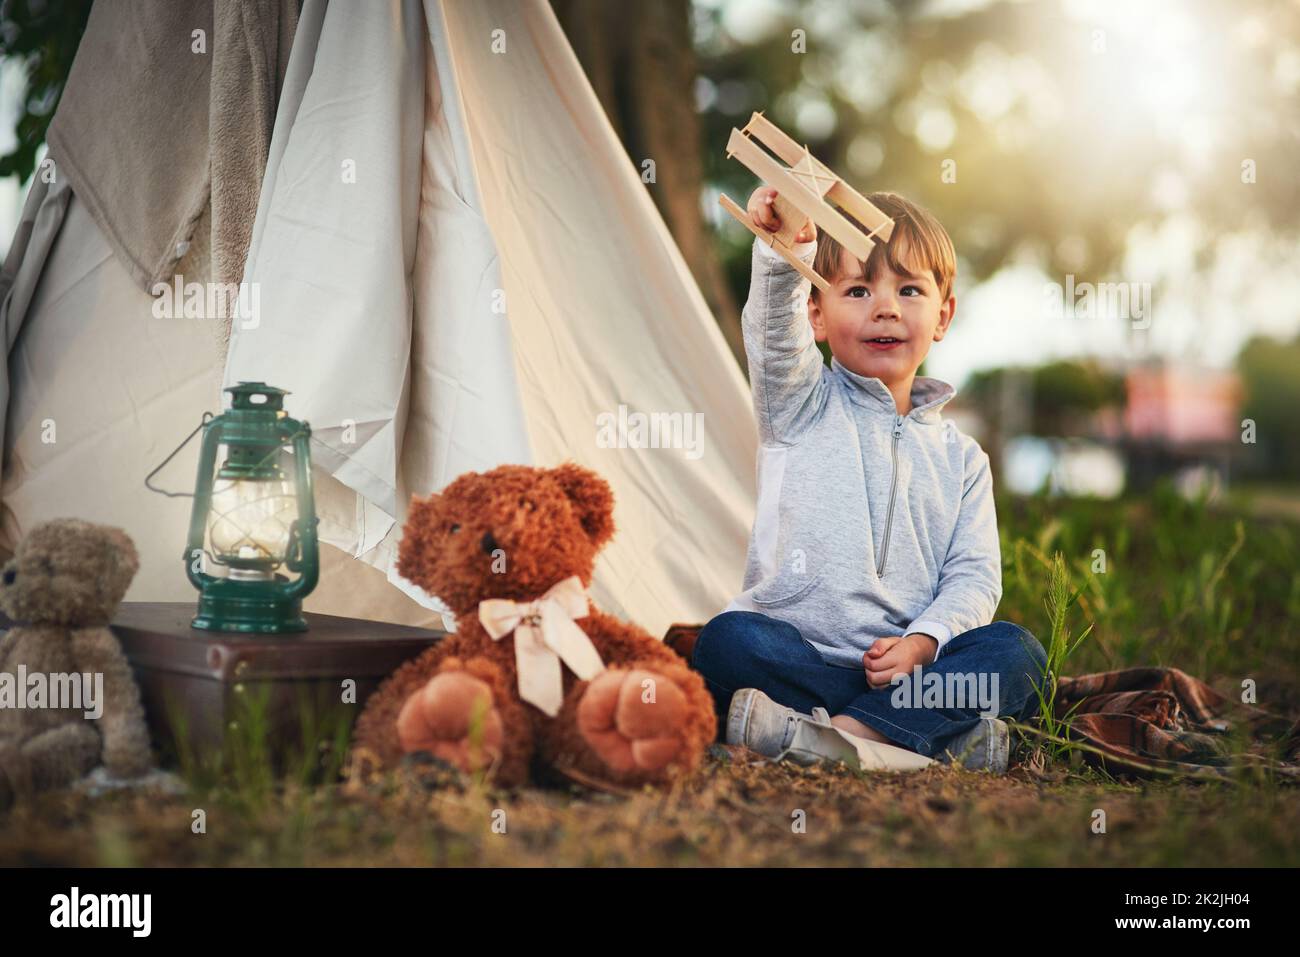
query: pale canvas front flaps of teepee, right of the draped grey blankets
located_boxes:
[226,0,754,631]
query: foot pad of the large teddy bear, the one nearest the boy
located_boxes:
[577,668,686,775]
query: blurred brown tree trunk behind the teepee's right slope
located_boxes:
[551,0,745,361]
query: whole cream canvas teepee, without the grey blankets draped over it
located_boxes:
[0,0,755,642]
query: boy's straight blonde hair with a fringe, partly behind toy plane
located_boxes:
[813,192,957,302]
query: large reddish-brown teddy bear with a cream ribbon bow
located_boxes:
[352,464,716,787]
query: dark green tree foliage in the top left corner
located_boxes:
[0,0,90,182]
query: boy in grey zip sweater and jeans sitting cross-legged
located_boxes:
[692,187,1047,774]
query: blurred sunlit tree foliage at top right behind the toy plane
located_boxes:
[696,0,1300,351]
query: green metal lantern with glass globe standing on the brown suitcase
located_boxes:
[185,382,320,633]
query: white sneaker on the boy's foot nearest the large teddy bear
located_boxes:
[727,688,935,771]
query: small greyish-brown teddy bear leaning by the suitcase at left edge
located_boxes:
[0,519,153,807]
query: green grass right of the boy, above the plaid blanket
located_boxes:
[997,482,1300,686]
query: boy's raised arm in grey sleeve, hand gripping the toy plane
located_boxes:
[741,189,827,445]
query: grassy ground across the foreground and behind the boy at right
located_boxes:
[0,489,1300,867]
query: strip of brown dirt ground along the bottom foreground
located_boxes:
[0,746,1300,866]
